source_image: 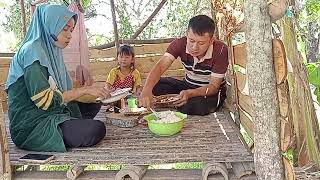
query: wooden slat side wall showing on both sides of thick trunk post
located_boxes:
[232,39,295,179]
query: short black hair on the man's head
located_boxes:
[188,15,216,37]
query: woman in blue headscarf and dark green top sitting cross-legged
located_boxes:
[6,5,110,152]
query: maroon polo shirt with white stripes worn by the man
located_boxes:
[164,37,229,86]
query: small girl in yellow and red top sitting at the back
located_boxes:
[106,45,142,96]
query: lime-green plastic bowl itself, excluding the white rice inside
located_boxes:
[143,112,187,136]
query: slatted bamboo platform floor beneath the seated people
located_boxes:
[7,109,253,165]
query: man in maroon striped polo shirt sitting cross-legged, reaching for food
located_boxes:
[139,15,228,115]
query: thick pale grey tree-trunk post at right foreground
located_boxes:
[244,0,284,180]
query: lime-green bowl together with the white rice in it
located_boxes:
[143,111,187,136]
